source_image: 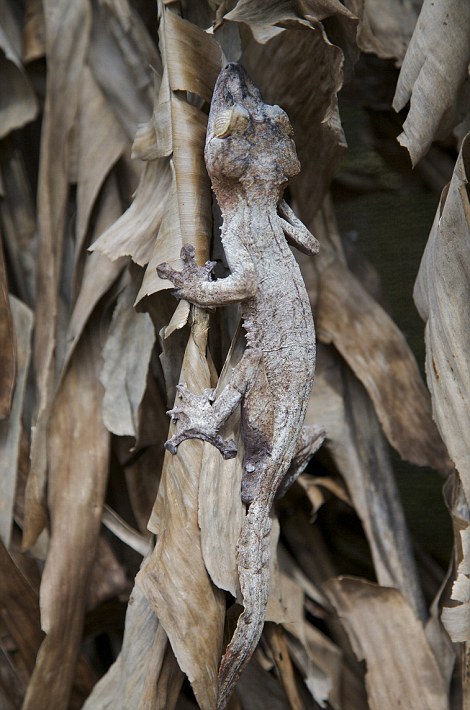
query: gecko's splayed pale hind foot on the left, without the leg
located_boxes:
[165,385,237,459]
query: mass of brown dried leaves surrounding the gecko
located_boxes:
[0,0,470,710]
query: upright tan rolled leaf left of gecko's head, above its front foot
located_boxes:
[137,4,220,300]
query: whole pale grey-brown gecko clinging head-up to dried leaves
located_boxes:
[157,62,324,710]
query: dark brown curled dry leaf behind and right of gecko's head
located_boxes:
[233,2,355,223]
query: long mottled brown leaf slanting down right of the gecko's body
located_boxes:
[316,202,449,478]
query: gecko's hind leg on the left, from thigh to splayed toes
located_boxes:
[165,348,262,459]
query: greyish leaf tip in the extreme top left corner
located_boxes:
[0,0,38,138]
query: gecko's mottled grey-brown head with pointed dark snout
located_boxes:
[204,62,300,191]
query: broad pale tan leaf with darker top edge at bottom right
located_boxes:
[327,577,449,710]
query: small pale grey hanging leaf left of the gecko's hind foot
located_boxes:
[100,284,155,438]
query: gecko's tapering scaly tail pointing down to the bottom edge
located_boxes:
[217,500,271,710]
